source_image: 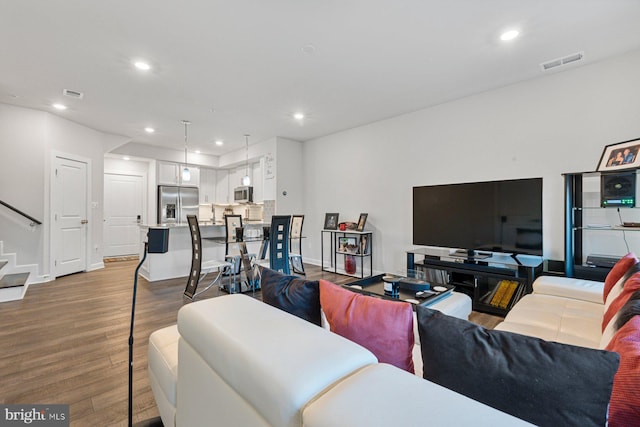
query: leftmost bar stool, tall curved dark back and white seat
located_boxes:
[184,215,231,301]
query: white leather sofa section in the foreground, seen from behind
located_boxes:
[149,294,528,427]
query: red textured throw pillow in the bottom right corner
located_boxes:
[606,316,640,427]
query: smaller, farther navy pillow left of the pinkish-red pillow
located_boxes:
[260,267,321,326]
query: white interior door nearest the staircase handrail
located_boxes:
[51,157,88,277]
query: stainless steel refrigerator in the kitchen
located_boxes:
[158,185,199,224]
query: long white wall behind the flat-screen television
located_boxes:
[304,51,640,272]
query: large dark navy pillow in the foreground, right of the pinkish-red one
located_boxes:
[416,306,620,427]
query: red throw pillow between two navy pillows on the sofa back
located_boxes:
[320,280,414,374]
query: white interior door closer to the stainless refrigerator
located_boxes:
[104,173,144,257]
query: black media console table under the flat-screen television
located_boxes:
[407,248,543,316]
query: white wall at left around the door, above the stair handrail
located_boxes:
[0,104,122,281]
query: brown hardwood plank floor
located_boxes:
[0,260,501,426]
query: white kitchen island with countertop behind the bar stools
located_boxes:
[140,221,268,284]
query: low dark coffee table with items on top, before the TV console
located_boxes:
[342,272,454,309]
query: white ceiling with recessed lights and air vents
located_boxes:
[0,0,640,155]
